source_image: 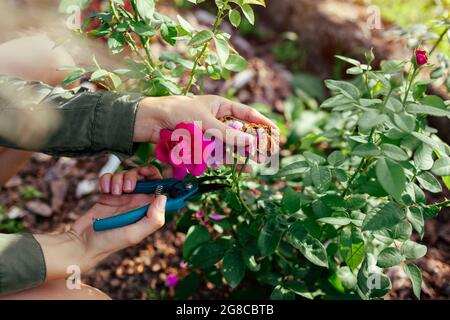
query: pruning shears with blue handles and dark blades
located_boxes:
[93,176,230,231]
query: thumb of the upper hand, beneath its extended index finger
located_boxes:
[204,117,256,147]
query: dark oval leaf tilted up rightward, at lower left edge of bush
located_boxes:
[190,238,230,269]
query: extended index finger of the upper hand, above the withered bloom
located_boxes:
[217,100,277,128]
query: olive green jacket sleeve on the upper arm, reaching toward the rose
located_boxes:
[0,75,141,158]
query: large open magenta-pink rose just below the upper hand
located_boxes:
[156,122,212,179]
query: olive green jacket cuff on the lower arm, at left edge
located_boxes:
[0,234,46,296]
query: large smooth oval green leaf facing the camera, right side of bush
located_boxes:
[375,158,406,199]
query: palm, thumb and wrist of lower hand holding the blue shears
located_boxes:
[35,194,166,281]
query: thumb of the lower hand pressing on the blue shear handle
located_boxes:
[125,195,167,244]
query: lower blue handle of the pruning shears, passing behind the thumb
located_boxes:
[93,197,186,231]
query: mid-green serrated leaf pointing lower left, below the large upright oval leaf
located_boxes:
[362,202,405,231]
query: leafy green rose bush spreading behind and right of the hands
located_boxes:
[59,0,450,299]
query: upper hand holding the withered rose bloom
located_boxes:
[134,95,278,146]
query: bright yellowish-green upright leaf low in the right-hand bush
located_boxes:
[339,228,366,270]
